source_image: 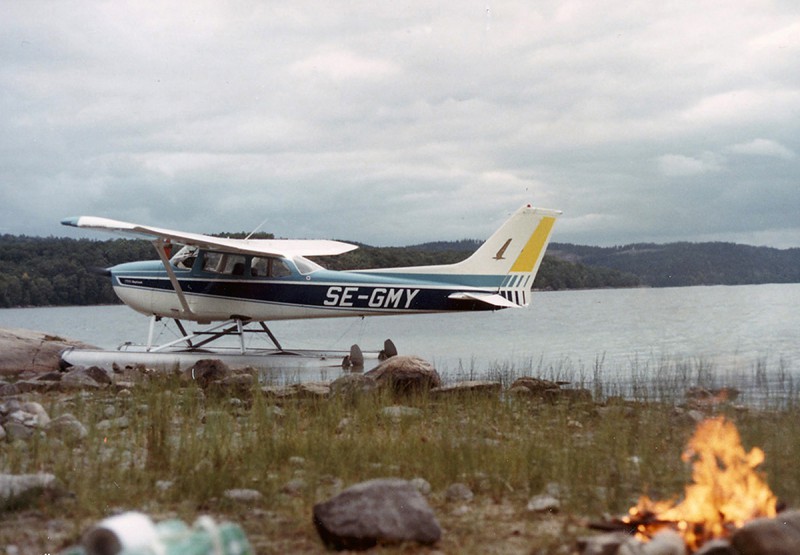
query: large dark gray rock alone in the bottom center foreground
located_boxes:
[314,478,442,550]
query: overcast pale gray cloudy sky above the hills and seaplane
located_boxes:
[0,0,800,248]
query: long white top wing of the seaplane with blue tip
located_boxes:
[61,216,358,257]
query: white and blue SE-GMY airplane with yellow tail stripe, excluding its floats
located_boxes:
[61,204,561,370]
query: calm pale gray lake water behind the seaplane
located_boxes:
[0,284,800,400]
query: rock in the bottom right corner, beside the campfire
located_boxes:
[731,511,800,555]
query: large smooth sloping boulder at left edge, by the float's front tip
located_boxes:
[0,328,95,376]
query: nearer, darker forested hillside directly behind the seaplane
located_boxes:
[0,234,639,308]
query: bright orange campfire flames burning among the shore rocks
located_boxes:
[623,417,776,550]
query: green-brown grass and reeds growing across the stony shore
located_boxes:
[0,359,800,553]
